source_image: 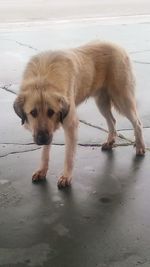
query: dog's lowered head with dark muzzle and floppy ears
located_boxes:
[14,81,69,145]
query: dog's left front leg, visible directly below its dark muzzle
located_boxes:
[32,145,50,182]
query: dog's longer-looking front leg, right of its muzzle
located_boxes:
[58,116,78,188]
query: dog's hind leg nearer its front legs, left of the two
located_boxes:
[95,88,117,150]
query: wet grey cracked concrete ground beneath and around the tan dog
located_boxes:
[0,14,150,267]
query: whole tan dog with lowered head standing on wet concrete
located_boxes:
[14,42,145,187]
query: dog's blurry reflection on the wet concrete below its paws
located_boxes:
[29,151,143,266]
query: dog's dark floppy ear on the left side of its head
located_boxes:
[13,95,27,124]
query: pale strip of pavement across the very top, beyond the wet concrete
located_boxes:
[0,0,150,23]
